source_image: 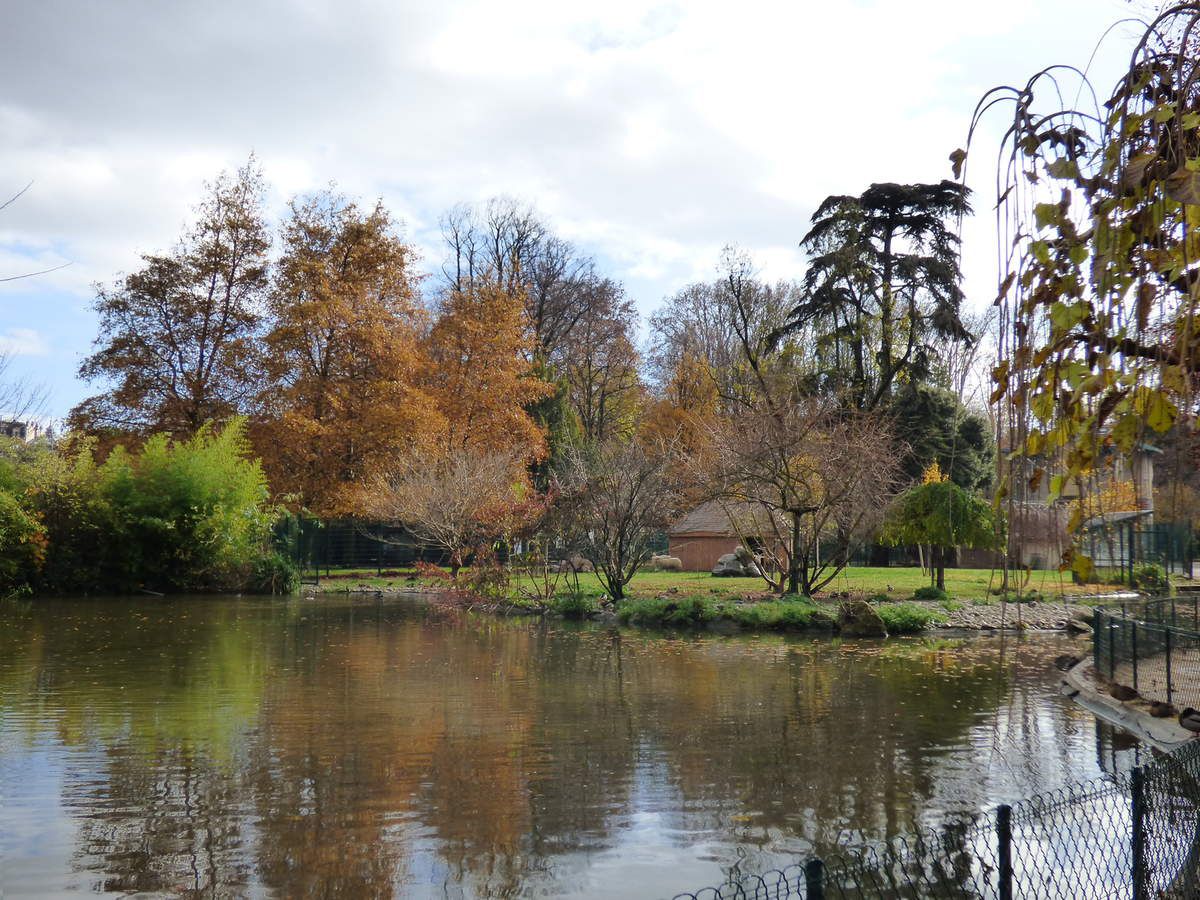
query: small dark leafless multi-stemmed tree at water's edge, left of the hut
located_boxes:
[562,440,682,602]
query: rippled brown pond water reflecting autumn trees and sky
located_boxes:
[0,598,1136,898]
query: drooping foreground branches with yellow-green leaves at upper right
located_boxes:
[952,2,1200,577]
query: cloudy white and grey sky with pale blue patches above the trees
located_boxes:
[0,0,1129,415]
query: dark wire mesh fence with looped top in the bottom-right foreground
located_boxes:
[676,744,1200,900]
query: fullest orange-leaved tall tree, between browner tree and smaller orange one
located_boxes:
[256,192,444,515]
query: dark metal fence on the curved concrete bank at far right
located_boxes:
[1093,595,1200,709]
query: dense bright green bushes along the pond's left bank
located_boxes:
[0,421,296,594]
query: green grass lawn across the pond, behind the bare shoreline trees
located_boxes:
[322,566,1114,600]
